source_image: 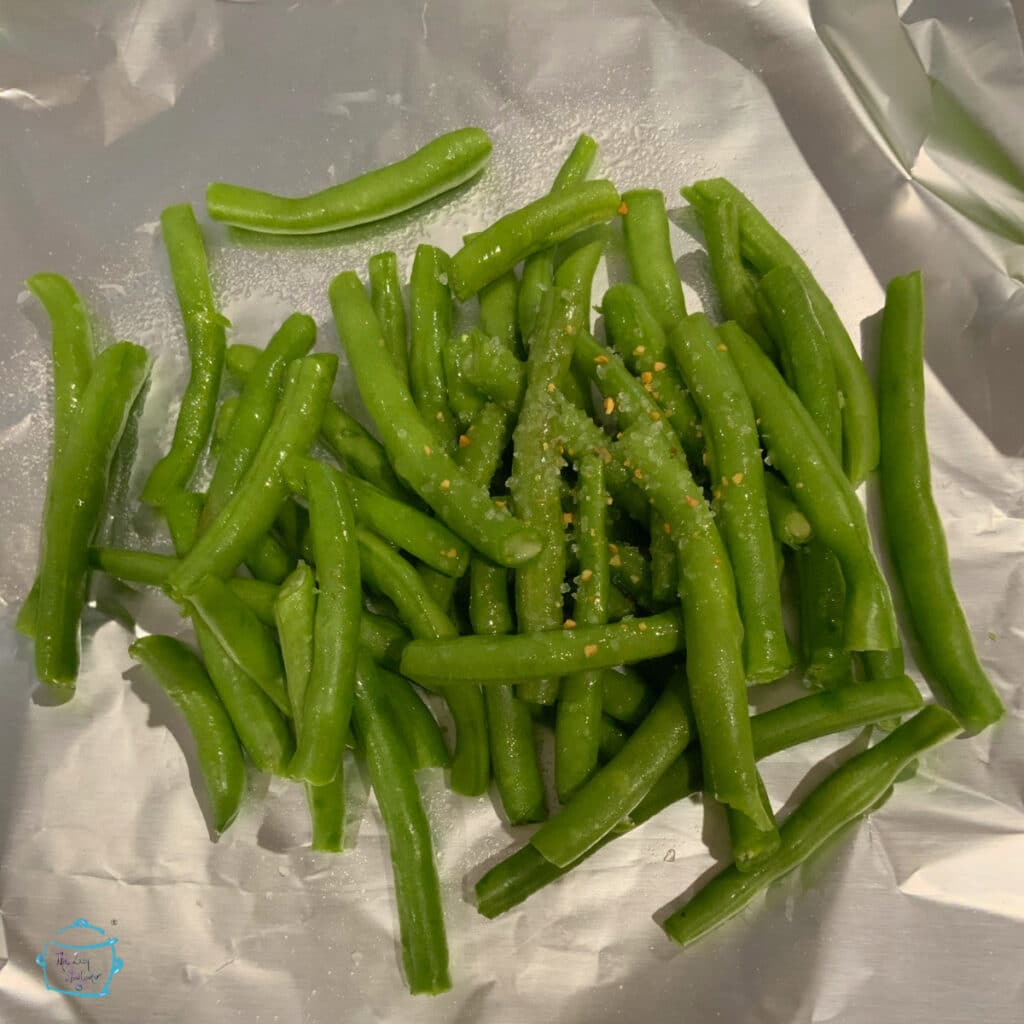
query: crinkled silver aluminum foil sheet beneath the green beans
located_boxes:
[0,0,1024,1024]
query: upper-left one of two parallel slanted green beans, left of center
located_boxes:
[200,313,316,530]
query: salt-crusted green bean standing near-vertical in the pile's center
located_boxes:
[510,243,601,705]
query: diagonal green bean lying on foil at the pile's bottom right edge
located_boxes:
[664,708,957,946]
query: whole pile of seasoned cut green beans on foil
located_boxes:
[17,128,1004,993]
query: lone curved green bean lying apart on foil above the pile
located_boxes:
[206,128,492,234]
